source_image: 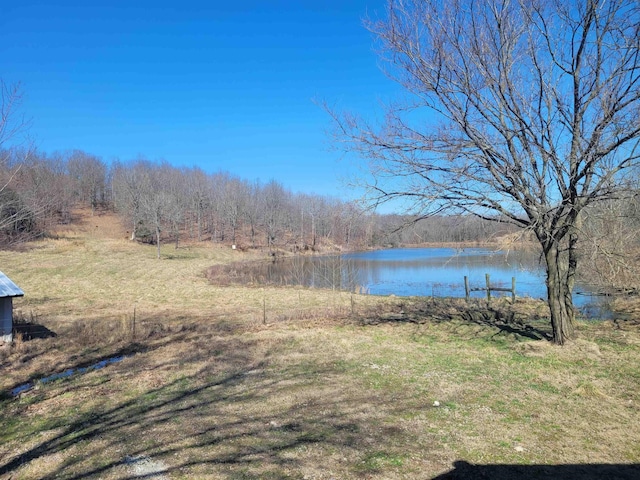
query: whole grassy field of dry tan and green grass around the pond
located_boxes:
[0,215,640,480]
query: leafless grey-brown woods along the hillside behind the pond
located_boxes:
[0,149,516,254]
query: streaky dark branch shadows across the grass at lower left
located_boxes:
[0,335,390,479]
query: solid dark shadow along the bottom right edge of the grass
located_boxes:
[432,461,640,480]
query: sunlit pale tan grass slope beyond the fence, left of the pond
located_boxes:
[0,213,344,324]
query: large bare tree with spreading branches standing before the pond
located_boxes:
[334,0,640,344]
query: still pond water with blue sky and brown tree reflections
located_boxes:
[261,248,606,316]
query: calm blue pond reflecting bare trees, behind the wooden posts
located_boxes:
[207,249,605,318]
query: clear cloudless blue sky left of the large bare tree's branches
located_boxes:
[0,0,397,197]
